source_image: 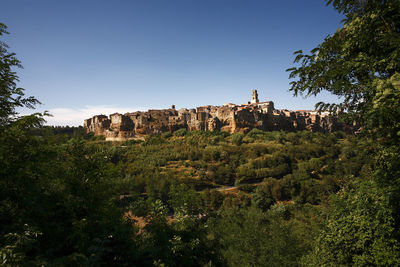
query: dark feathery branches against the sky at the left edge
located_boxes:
[0,23,40,127]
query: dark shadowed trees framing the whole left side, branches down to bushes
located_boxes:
[0,24,141,266]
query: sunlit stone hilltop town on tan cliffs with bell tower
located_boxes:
[84,90,344,140]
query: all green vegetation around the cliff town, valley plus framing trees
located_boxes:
[0,0,400,266]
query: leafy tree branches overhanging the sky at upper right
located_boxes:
[287,0,400,122]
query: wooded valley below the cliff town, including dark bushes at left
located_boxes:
[1,123,368,265]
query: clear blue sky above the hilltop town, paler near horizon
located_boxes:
[0,0,341,125]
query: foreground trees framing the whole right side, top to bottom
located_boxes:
[288,0,400,266]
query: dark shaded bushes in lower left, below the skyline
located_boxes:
[0,127,138,263]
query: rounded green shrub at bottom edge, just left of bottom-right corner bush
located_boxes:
[211,205,313,266]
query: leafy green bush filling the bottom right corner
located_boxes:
[304,181,400,266]
